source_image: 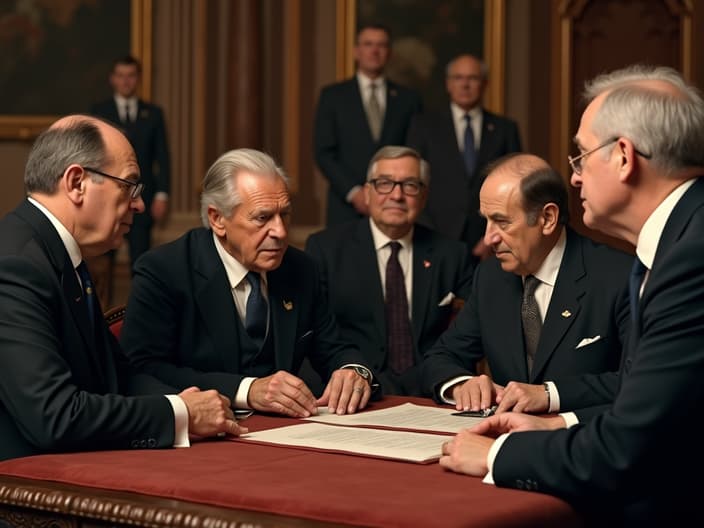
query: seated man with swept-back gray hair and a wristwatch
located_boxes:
[121,149,372,417]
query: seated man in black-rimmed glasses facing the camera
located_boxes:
[306,146,472,396]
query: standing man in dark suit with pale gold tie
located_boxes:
[314,25,421,226]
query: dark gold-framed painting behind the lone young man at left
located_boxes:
[0,0,152,140]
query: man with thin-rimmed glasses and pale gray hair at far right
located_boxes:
[440,66,704,527]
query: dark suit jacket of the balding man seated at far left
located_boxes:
[0,201,174,459]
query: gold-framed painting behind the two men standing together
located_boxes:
[336,0,505,113]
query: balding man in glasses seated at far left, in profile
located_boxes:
[0,116,242,460]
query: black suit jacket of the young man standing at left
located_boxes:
[90,97,171,208]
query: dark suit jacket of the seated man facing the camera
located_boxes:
[306,218,472,395]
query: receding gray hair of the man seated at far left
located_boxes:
[24,116,107,195]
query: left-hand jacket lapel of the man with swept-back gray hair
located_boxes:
[193,230,241,372]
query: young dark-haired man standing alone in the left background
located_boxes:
[90,56,171,270]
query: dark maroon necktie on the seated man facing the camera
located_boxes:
[386,242,413,374]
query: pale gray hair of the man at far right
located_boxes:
[584,65,704,173]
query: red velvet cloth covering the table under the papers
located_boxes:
[0,397,582,527]
